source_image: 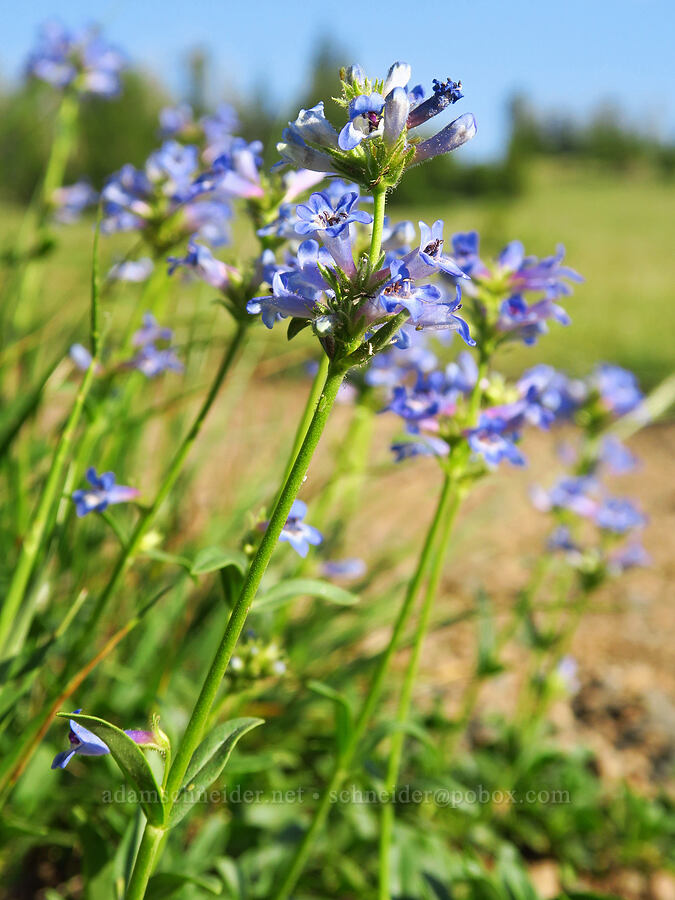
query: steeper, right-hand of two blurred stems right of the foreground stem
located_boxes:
[379,486,462,900]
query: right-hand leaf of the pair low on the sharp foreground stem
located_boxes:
[169,718,263,828]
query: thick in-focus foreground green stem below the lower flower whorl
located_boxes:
[126,365,345,900]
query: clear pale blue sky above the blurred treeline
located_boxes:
[0,0,675,157]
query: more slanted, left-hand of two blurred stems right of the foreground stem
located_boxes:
[274,477,452,900]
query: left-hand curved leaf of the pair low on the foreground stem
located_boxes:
[57,712,164,825]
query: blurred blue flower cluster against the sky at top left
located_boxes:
[27,22,125,97]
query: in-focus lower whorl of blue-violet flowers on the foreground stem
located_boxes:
[248,191,475,355]
